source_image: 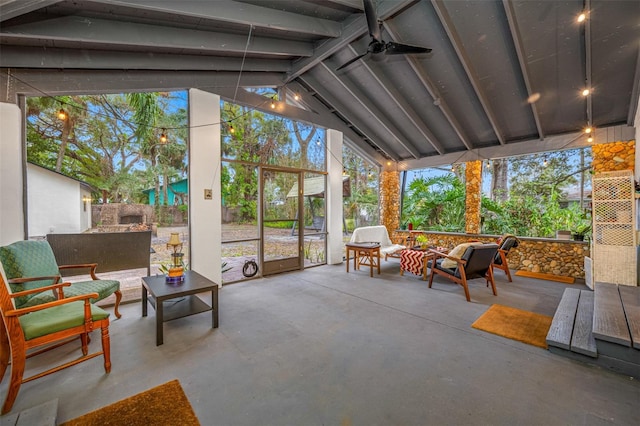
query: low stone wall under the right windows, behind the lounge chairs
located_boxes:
[394,231,589,280]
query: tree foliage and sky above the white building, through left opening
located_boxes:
[27,93,187,202]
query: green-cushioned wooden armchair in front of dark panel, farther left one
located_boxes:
[0,240,122,318]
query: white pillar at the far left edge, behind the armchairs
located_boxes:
[0,102,25,245]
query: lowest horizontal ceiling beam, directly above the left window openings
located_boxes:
[0,69,282,102]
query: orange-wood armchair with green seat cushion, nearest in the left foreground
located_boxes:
[0,264,111,414]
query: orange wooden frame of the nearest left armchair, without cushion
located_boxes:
[0,274,111,414]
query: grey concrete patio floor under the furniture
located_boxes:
[0,259,640,425]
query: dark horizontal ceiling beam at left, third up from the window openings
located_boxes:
[0,16,313,57]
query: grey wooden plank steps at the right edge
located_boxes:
[547,283,640,377]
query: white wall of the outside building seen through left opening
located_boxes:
[27,164,91,238]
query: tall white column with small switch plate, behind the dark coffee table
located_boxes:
[189,89,222,285]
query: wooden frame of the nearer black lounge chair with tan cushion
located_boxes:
[429,244,498,302]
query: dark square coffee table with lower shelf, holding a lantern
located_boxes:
[142,271,218,346]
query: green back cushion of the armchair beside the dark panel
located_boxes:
[0,241,60,308]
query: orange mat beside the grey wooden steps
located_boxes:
[471,305,553,349]
